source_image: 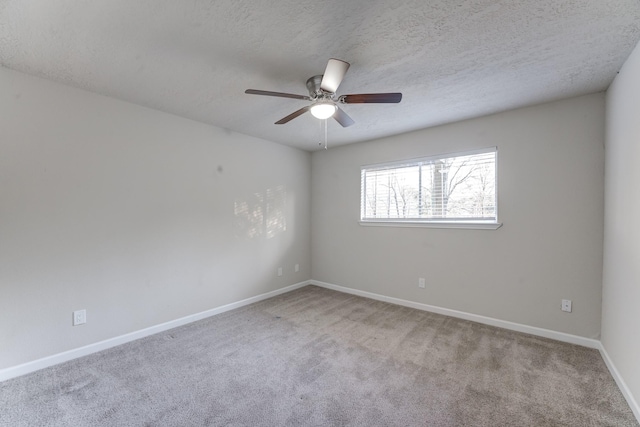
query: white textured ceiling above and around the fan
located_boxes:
[0,0,640,150]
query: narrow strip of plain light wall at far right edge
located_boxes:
[602,41,640,416]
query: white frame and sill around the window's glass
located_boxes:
[359,146,502,230]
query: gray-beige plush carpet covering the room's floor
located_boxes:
[0,286,638,427]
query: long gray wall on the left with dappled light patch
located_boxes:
[0,68,311,369]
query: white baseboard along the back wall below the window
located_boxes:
[310,280,601,349]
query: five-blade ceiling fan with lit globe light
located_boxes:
[244,58,402,127]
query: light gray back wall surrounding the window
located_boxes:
[311,93,605,338]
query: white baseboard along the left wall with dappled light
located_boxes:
[0,280,311,381]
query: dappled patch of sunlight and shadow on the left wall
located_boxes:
[234,185,287,239]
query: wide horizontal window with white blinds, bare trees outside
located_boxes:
[360,147,500,228]
